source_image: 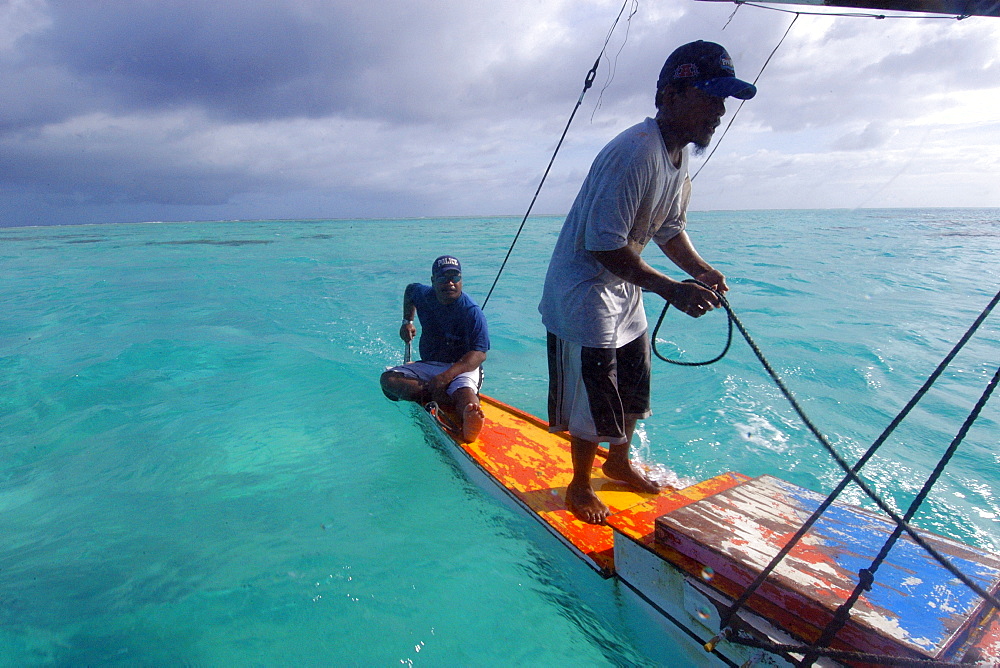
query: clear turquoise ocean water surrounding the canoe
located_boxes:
[0,209,1000,666]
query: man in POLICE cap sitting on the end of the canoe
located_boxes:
[381,255,490,443]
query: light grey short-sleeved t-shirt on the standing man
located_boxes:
[538,118,691,348]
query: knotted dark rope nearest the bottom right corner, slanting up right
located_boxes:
[801,367,1000,666]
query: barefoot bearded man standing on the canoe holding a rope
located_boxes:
[538,41,757,524]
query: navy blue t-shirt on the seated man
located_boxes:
[409,283,490,364]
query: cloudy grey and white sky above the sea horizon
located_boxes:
[0,0,1000,226]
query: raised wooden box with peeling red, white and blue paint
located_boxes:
[657,476,1000,658]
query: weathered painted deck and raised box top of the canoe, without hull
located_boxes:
[420,395,1000,661]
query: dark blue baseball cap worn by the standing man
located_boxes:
[656,40,757,100]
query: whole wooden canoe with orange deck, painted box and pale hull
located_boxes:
[419,396,1000,666]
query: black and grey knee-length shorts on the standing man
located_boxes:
[548,332,650,445]
